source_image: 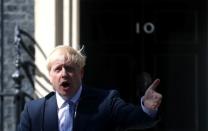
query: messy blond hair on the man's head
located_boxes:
[47,45,86,71]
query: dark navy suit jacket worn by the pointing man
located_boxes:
[18,88,157,131]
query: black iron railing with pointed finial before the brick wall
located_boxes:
[0,26,34,131]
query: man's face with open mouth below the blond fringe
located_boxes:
[49,53,83,98]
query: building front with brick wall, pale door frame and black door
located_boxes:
[0,0,208,131]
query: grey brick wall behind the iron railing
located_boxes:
[0,0,34,131]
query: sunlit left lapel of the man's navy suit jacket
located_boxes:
[44,95,58,131]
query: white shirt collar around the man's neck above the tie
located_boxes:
[56,85,82,109]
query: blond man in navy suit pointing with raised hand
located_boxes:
[18,46,162,131]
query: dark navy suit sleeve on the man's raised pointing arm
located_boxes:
[110,90,158,129]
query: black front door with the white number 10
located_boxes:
[81,0,207,131]
